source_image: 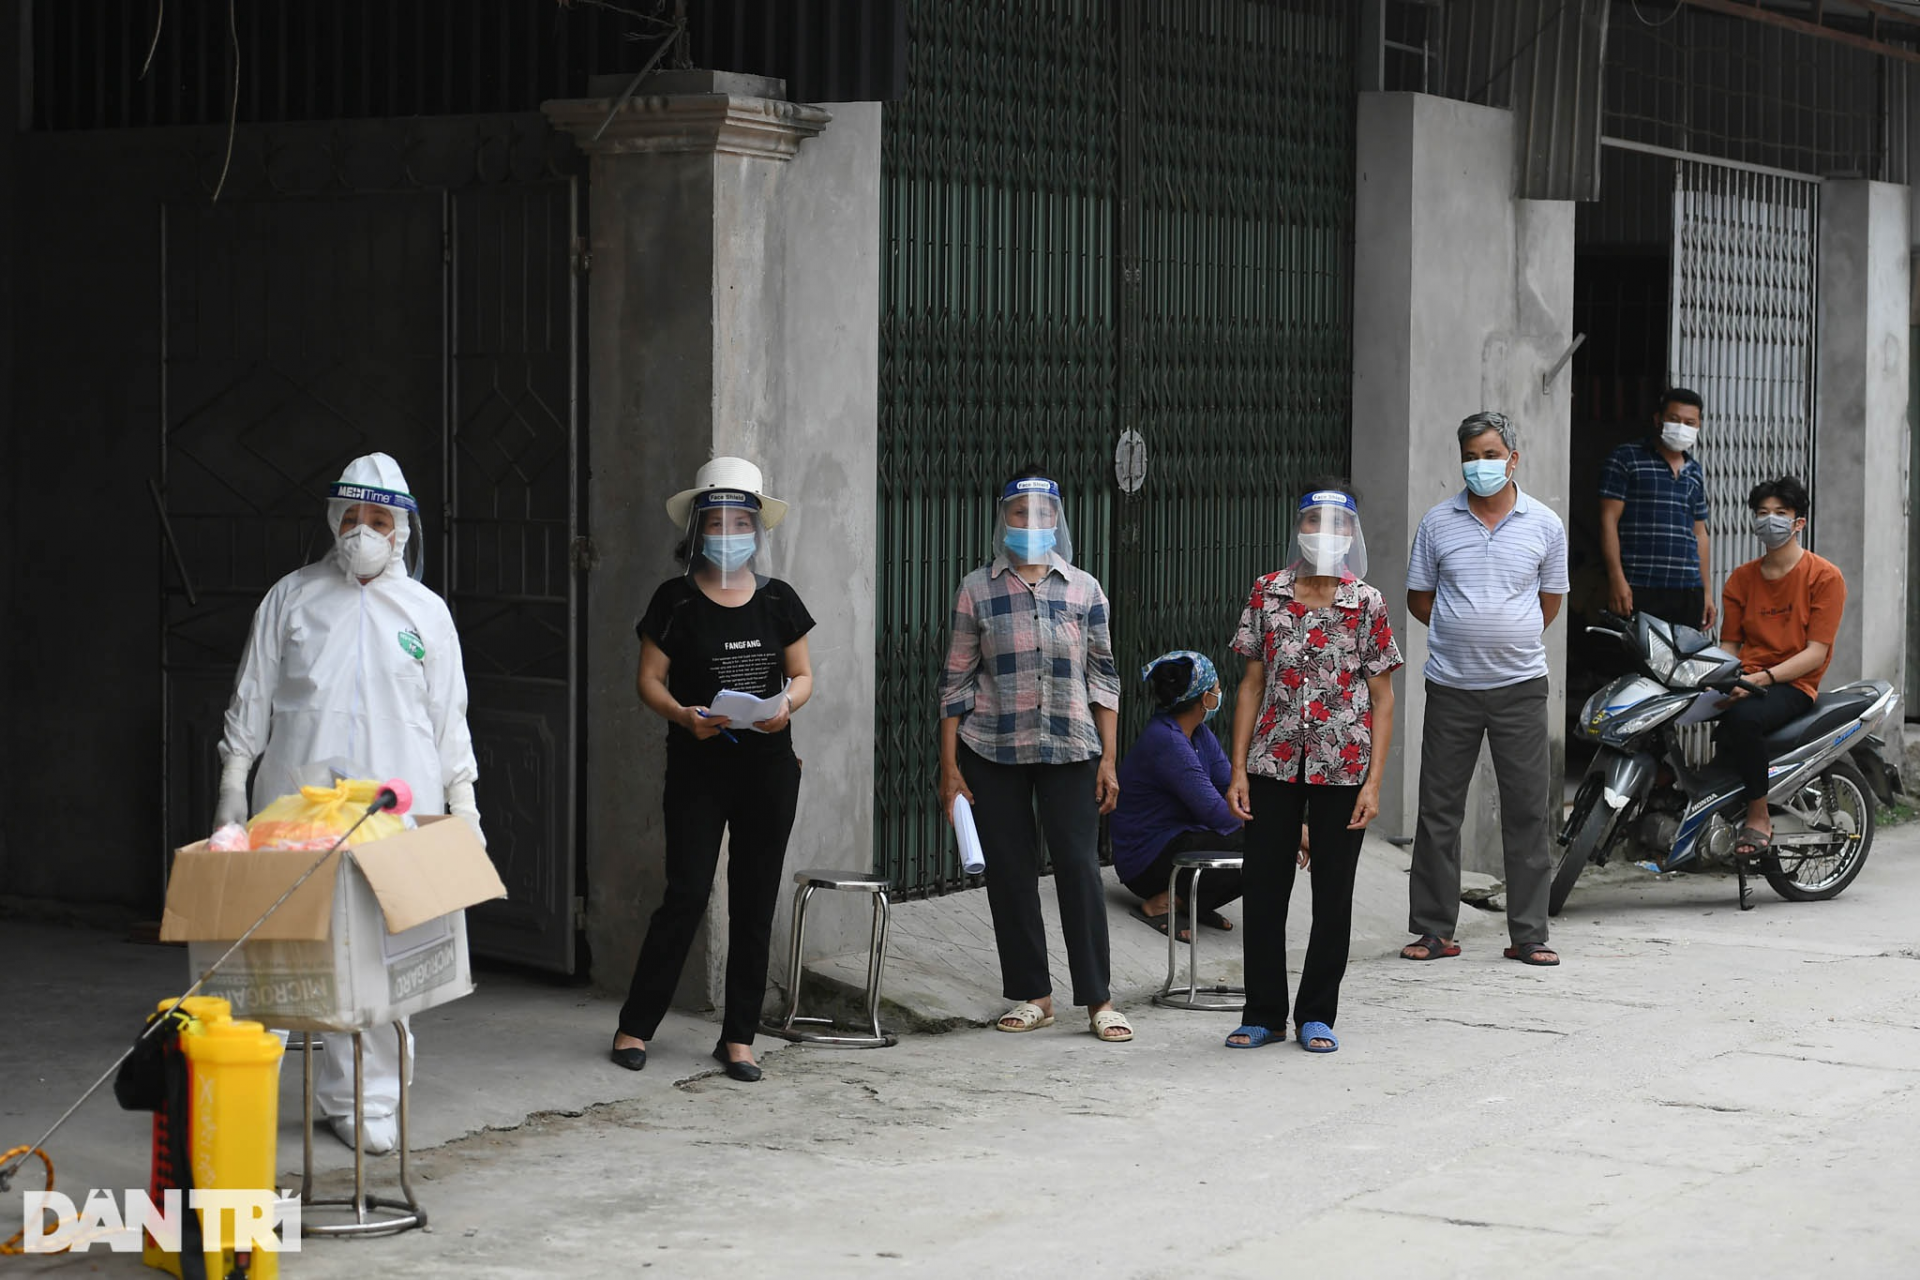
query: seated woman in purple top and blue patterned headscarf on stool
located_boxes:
[1112,649,1246,942]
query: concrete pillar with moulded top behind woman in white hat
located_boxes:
[543,71,879,1007]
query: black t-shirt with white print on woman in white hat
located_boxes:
[634,578,814,752]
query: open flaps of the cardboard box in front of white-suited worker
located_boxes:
[159,814,507,942]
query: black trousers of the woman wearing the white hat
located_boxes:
[620,750,801,1044]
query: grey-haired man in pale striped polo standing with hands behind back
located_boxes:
[1400,413,1567,965]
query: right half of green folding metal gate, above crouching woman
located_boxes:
[1114,0,1354,745]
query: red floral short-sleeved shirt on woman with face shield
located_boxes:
[1233,568,1402,787]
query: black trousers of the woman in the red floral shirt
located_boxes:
[1236,777,1367,1031]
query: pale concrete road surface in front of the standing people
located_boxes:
[0,827,1920,1280]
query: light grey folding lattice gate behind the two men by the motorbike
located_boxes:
[1668,159,1820,762]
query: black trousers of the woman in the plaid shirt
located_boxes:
[960,745,1112,1006]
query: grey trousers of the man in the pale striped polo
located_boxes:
[1407,676,1553,946]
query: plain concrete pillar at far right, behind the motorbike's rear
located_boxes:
[1812,178,1912,702]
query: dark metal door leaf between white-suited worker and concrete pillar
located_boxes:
[445,180,582,973]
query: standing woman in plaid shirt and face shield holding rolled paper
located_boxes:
[941,466,1133,1042]
